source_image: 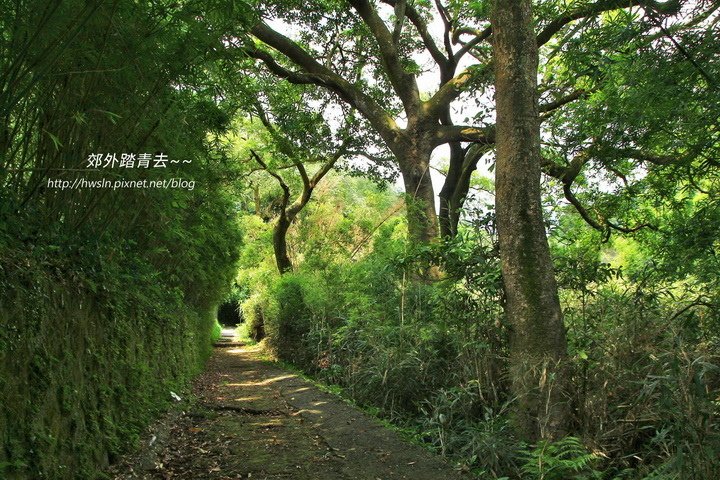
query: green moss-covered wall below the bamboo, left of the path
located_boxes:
[0,260,219,479]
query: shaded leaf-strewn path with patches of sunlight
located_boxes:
[110,333,467,480]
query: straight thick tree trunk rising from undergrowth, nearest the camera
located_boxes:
[491,0,568,441]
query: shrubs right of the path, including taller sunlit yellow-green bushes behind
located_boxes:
[238,169,720,479]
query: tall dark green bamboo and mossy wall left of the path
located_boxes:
[0,1,240,479]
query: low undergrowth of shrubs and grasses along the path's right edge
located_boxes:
[238,218,720,480]
